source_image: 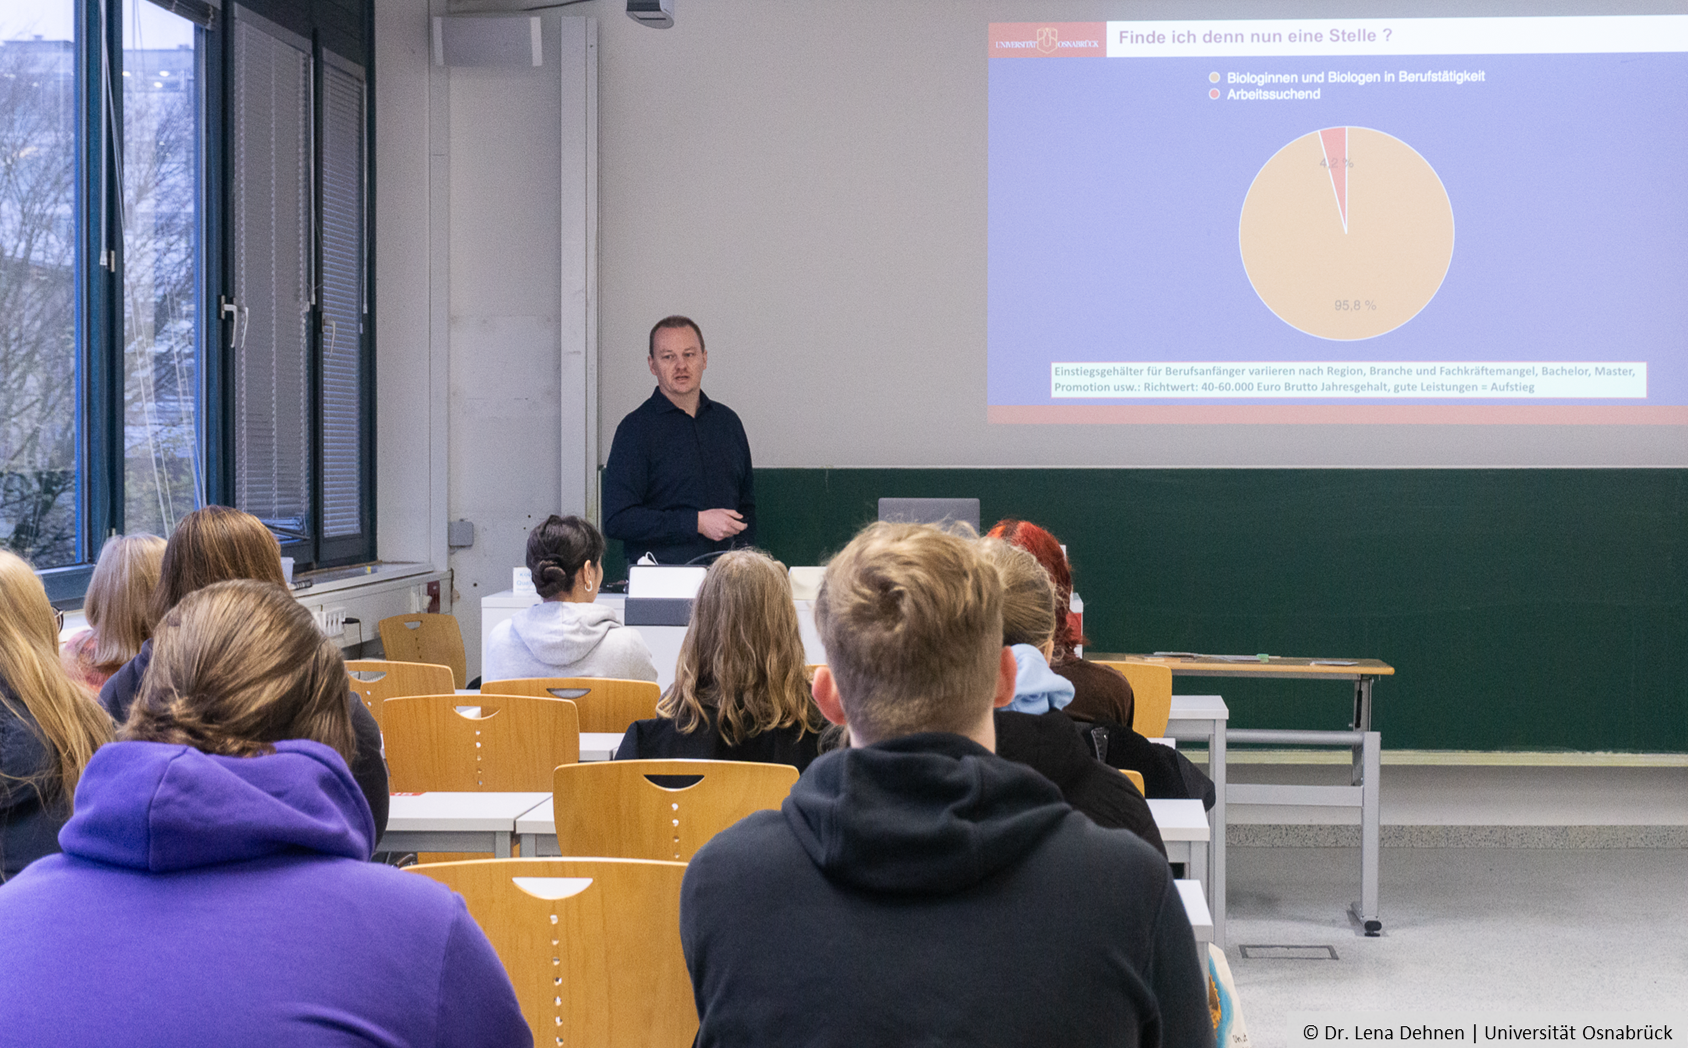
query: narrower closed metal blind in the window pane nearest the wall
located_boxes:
[321,56,365,538]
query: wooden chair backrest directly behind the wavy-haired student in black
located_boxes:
[552,761,797,862]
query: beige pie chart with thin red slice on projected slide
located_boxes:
[1239,127,1453,341]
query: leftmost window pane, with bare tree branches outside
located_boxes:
[0,0,78,567]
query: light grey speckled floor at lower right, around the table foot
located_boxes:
[1227,847,1688,1048]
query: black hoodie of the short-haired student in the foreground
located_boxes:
[680,734,1214,1048]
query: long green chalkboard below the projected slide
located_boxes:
[608,469,1688,753]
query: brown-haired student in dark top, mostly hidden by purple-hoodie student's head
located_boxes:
[100,506,388,840]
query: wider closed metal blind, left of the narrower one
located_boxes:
[230,19,314,533]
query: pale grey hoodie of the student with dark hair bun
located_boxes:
[481,601,657,680]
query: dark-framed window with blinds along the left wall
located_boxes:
[0,0,375,599]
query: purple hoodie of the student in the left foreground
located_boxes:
[0,741,532,1048]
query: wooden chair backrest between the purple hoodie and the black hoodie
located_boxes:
[410,859,697,1048]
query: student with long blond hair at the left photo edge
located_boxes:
[0,550,111,877]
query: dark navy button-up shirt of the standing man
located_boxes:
[604,388,756,564]
